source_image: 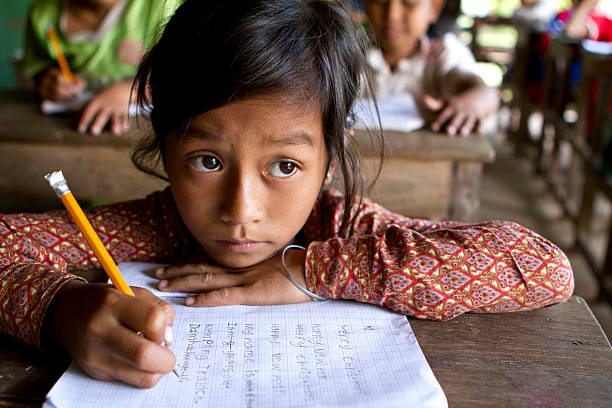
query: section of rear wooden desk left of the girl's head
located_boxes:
[0,91,166,201]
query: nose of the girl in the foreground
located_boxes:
[220,176,263,225]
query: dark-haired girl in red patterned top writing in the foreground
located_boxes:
[0,0,573,387]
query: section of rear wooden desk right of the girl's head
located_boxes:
[355,129,495,221]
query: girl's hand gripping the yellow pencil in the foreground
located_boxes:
[50,281,176,388]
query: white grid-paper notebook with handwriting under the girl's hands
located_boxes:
[44,264,448,408]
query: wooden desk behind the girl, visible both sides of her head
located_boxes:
[0,91,495,221]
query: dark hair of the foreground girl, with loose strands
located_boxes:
[132,0,380,235]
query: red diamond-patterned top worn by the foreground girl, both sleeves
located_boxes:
[0,190,574,347]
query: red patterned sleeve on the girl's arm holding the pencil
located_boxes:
[0,192,188,347]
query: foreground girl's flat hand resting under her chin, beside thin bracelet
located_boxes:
[155,250,310,306]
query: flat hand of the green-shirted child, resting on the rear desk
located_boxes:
[78,81,132,135]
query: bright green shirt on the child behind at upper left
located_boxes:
[22,0,181,89]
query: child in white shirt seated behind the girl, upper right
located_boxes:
[365,0,499,135]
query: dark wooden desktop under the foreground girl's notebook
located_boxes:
[0,297,612,408]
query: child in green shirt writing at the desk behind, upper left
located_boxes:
[22,0,179,134]
